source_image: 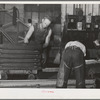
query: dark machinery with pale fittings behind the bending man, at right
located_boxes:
[62,15,100,78]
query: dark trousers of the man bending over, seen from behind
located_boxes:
[56,46,85,88]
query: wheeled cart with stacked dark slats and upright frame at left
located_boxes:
[0,7,41,79]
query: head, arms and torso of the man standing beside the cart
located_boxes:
[24,16,52,48]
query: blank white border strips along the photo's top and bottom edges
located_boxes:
[0,0,100,100]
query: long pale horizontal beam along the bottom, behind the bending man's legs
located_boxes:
[0,79,95,88]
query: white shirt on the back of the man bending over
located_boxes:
[65,41,86,56]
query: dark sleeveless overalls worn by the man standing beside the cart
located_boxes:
[32,24,50,67]
